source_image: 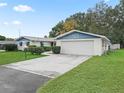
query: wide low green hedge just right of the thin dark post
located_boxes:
[25,47,44,55]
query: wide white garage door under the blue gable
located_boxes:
[61,40,94,55]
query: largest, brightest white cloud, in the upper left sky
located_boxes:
[13,5,34,12]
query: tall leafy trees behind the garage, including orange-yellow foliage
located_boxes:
[49,0,124,47]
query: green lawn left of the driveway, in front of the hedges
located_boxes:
[0,51,46,65]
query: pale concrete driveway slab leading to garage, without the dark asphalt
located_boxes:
[5,55,90,78]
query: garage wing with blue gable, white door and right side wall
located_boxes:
[55,30,111,55]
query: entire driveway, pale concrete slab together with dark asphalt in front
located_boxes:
[0,55,90,93]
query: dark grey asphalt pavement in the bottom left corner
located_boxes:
[0,66,50,93]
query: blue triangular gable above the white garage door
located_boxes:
[57,32,99,40]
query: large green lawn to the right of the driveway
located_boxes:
[37,49,124,93]
